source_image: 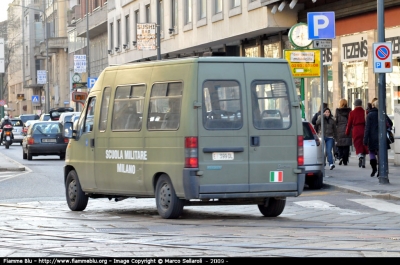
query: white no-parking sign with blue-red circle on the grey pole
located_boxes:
[372,42,393,73]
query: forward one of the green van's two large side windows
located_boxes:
[111,85,146,131]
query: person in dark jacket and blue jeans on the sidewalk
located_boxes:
[316,108,337,170]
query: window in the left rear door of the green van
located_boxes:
[202,80,243,130]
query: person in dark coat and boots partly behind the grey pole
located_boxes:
[363,100,393,177]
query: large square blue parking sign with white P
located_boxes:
[307,12,336,40]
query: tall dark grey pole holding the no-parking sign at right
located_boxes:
[377,0,389,184]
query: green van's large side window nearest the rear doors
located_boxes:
[147,82,183,130]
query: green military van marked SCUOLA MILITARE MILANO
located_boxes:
[64,57,305,218]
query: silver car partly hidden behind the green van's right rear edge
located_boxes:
[303,121,323,189]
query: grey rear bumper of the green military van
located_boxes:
[183,169,305,200]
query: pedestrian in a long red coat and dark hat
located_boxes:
[346,98,368,168]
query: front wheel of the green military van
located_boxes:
[65,170,89,211]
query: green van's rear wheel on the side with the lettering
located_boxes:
[156,174,184,219]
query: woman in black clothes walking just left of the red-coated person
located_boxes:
[335,98,352,166]
